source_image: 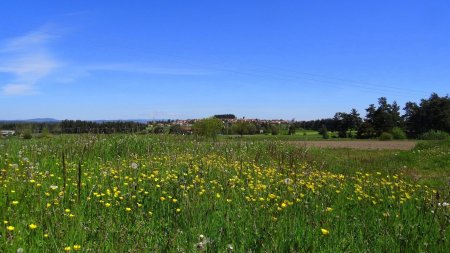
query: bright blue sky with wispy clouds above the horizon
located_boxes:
[0,0,450,120]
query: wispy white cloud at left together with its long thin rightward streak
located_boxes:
[0,25,212,96]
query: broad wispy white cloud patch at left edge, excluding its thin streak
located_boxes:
[0,27,61,95]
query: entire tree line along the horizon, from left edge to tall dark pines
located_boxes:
[0,93,450,139]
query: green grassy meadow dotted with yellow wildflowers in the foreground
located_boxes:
[0,135,450,252]
